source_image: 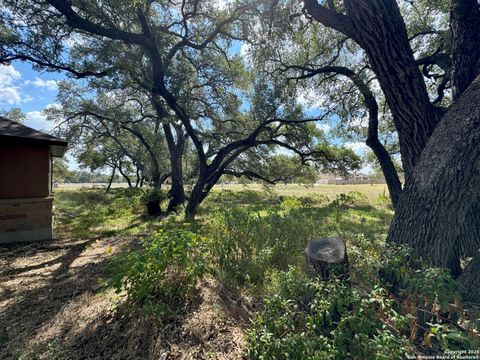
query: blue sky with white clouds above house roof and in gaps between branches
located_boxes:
[0,61,370,172]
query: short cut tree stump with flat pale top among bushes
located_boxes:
[305,237,350,281]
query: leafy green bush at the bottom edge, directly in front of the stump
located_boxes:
[247,267,412,359]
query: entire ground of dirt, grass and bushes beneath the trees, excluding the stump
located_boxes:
[0,185,480,359]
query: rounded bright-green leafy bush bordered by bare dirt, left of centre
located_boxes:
[108,229,209,314]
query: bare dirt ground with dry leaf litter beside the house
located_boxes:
[0,237,249,360]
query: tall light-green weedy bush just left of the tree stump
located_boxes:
[201,209,325,288]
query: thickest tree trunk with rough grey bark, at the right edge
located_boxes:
[388,77,480,301]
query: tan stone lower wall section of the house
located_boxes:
[0,198,53,244]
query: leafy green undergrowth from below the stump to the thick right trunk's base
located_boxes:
[247,239,478,360]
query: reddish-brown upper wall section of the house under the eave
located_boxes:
[0,142,50,199]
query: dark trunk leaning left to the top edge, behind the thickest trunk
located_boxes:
[344,0,437,183]
